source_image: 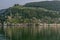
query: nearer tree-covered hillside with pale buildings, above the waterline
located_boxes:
[0,6,60,23]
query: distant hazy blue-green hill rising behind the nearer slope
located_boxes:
[24,1,60,11]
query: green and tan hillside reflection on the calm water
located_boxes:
[0,23,60,40]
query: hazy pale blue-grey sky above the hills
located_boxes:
[0,0,52,9]
